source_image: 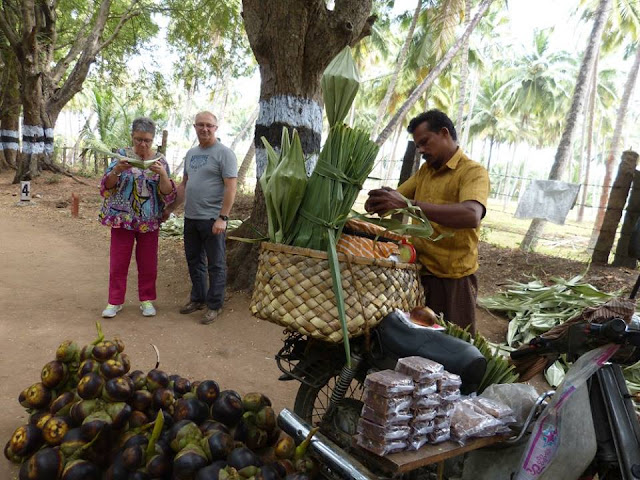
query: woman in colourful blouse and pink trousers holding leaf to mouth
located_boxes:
[99,117,176,318]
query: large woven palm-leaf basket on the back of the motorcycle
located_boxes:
[250,242,424,342]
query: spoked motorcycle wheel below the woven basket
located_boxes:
[293,375,364,446]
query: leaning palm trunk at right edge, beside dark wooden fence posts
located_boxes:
[591,42,640,263]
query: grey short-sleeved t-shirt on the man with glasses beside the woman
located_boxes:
[184,142,238,220]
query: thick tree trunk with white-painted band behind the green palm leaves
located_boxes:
[228,0,375,289]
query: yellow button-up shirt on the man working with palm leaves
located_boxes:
[398,147,489,278]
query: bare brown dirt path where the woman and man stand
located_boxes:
[0,185,295,479]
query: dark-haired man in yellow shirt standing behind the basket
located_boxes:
[365,110,489,333]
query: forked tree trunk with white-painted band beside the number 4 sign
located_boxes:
[0,0,140,183]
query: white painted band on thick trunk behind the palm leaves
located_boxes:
[256,95,322,135]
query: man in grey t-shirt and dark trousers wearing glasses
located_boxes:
[166,112,238,324]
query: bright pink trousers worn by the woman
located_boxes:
[109,228,159,305]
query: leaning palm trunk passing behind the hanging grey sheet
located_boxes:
[520,0,611,251]
